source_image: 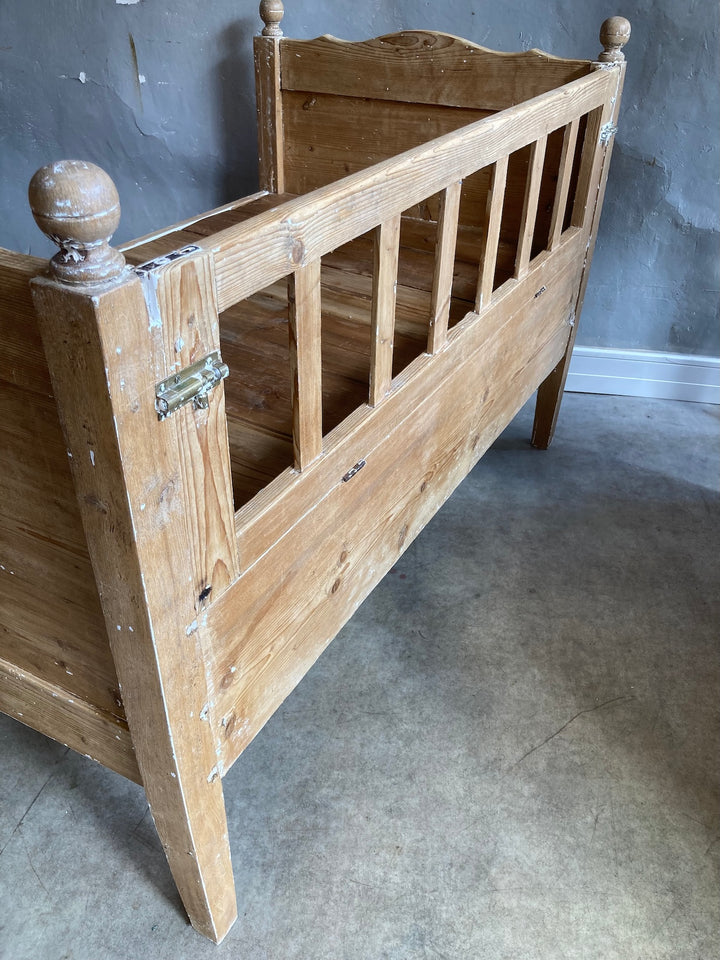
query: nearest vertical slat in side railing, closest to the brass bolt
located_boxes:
[288,260,322,470]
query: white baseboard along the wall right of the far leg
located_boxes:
[565,346,720,403]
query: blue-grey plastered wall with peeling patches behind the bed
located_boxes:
[0,0,720,355]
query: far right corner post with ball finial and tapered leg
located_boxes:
[531,17,630,450]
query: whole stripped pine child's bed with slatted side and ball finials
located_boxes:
[0,0,630,942]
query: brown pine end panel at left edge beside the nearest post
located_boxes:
[0,250,124,732]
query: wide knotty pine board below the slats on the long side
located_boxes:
[207,236,581,768]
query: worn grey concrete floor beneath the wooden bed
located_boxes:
[0,394,720,960]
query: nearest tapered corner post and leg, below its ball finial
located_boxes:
[33,275,236,940]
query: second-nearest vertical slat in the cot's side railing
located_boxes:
[368,215,401,407]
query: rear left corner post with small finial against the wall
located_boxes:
[253,0,285,193]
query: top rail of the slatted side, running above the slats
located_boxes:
[200,73,612,311]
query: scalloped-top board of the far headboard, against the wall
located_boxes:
[280,30,591,110]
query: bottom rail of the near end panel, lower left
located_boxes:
[0,659,142,783]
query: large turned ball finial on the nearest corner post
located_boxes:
[28,160,125,284]
